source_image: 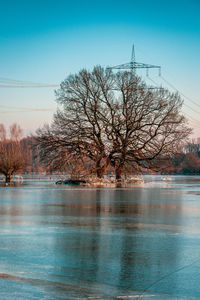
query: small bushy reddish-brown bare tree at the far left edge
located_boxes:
[0,124,26,183]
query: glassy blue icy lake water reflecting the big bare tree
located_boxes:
[0,176,200,300]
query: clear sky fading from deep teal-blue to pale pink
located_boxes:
[0,0,200,136]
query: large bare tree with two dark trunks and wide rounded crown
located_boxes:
[37,67,191,180]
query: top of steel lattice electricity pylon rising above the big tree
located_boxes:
[107,44,161,76]
